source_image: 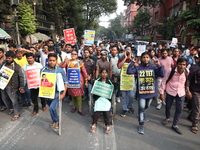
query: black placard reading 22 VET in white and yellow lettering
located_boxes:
[138,70,155,94]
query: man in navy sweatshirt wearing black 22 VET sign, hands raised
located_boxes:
[127,52,164,134]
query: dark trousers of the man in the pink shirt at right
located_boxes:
[165,93,185,126]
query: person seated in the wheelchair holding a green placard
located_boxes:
[89,68,117,134]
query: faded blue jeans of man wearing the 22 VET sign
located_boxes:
[138,98,152,125]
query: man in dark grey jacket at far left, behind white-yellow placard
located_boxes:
[0,51,25,121]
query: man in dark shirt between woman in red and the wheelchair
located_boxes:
[83,49,95,101]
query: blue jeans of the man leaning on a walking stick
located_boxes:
[46,98,59,122]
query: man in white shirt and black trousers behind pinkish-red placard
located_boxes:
[22,53,47,116]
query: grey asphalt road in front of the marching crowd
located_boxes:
[0,98,200,150]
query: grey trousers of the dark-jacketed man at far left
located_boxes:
[1,86,19,115]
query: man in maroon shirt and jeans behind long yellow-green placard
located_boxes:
[117,46,136,117]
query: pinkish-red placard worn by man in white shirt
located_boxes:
[26,69,40,89]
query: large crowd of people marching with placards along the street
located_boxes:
[0,36,200,134]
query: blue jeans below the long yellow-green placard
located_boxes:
[121,82,136,111]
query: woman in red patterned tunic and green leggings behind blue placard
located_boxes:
[60,50,88,116]
